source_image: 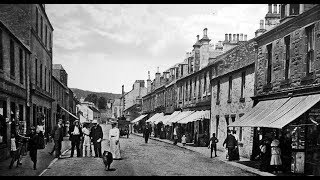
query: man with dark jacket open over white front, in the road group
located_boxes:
[68,120,82,157]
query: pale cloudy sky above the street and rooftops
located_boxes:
[46,4,268,94]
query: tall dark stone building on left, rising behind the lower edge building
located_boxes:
[0,4,53,139]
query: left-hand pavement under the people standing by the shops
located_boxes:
[0,137,71,176]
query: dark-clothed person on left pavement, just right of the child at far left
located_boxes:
[27,126,39,170]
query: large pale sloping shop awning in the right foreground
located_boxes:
[229,94,320,129]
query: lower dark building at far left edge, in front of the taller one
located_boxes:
[0,19,31,160]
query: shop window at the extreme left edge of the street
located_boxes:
[0,100,7,144]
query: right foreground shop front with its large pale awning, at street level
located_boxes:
[229,94,320,176]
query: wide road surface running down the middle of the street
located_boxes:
[42,135,256,176]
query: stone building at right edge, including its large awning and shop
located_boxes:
[230,4,320,175]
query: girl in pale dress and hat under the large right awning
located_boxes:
[270,138,282,173]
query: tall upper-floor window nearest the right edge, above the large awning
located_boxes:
[306,25,314,76]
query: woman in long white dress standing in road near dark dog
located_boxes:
[109,122,121,160]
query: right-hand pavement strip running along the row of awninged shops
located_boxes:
[131,133,276,176]
